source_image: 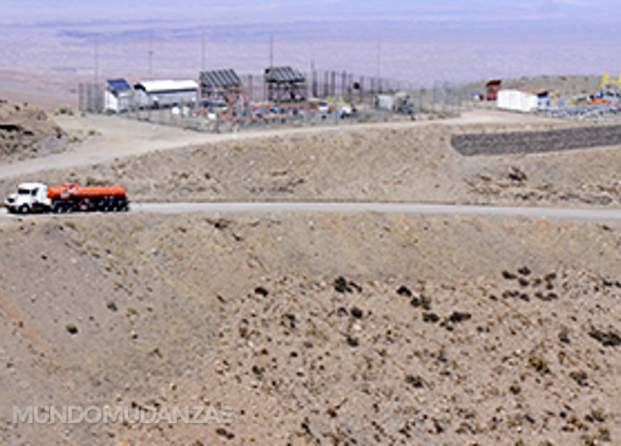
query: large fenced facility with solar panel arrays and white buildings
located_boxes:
[79,57,464,132]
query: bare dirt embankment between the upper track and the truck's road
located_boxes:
[0,123,621,206]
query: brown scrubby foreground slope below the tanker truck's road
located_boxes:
[0,214,621,445]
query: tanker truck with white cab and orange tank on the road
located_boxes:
[4,183,129,214]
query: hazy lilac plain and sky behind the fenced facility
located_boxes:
[0,0,621,101]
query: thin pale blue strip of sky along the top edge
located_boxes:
[0,0,620,25]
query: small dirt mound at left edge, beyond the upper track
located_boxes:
[0,100,67,162]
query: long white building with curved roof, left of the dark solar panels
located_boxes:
[134,80,198,108]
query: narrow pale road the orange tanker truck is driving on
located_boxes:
[0,203,621,221]
